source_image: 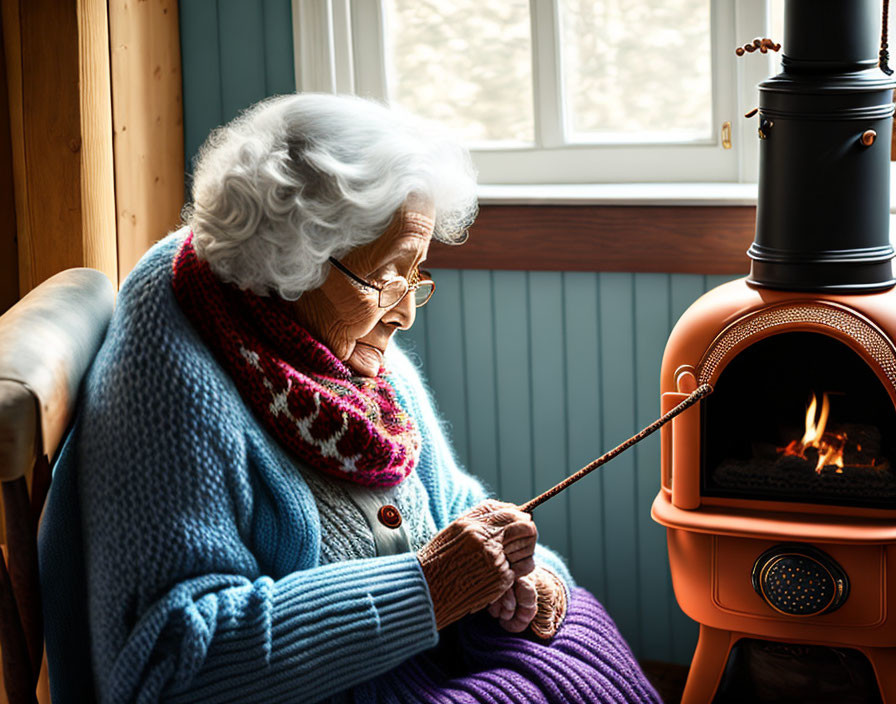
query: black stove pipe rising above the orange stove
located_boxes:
[747,0,896,293]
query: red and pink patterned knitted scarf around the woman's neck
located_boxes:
[172,233,420,487]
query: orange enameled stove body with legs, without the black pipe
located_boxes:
[653,279,896,704]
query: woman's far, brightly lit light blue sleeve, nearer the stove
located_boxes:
[389,346,574,589]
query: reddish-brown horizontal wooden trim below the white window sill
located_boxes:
[427,205,756,274]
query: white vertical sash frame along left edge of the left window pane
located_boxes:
[351,0,389,100]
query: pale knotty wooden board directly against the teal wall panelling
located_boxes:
[109,0,184,279]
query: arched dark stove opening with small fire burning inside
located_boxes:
[702,332,896,508]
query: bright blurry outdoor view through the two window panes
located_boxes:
[385,0,713,146]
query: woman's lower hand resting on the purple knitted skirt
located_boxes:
[488,566,566,639]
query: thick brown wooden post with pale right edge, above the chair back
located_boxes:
[0,0,117,295]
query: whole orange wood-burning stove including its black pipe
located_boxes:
[652,0,896,704]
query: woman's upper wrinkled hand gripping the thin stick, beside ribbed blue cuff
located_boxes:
[417,501,538,630]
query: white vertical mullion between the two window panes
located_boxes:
[529,0,565,148]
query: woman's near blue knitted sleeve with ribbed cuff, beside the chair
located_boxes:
[78,248,438,703]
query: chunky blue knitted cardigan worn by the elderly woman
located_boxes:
[40,233,572,704]
